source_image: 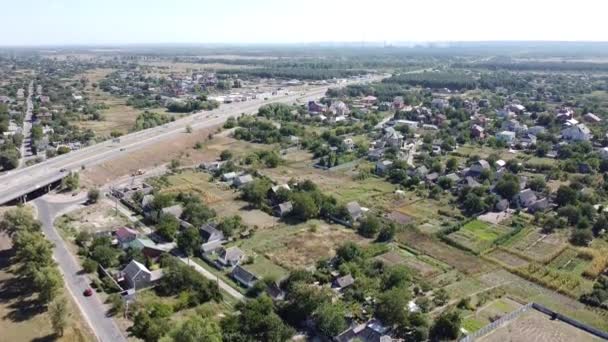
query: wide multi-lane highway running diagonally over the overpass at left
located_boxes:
[0,76,382,204]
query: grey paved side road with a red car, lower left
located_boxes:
[33,196,126,342]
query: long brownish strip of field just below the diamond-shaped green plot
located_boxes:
[397,229,493,274]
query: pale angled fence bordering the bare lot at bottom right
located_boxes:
[459,303,608,342]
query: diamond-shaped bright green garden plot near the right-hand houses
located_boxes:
[447,220,511,253]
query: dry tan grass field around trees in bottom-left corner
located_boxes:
[0,235,95,342]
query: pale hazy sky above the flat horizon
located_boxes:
[0,0,608,46]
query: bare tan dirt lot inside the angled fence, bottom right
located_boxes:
[478,310,603,342]
